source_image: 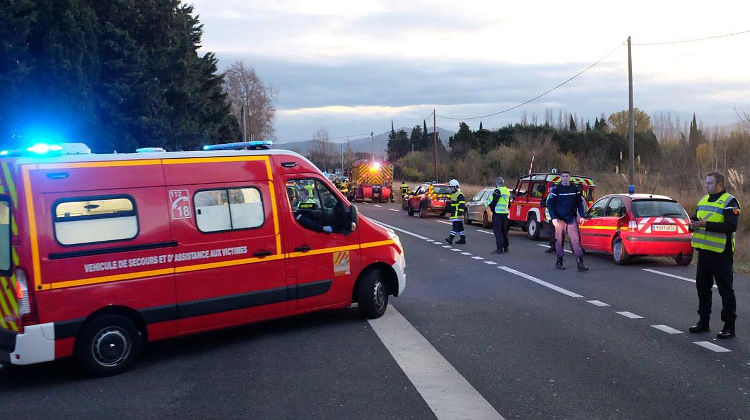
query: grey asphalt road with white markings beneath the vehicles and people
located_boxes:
[0,204,750,419]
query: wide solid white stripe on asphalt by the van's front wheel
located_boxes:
[369,306,503,419]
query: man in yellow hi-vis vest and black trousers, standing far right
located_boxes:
[690,172,740,338]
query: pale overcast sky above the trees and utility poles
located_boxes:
[188,0,750,142]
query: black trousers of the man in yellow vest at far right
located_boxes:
[695,250,737,322]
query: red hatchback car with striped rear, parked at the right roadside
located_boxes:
[579,194,693,265]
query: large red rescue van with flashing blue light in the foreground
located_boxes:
[0,142,406,375]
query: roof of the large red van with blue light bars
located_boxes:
[5,149,307,165]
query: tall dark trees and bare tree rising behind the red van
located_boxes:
[0,0,273,152]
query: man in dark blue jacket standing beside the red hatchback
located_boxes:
[547,171,589,271]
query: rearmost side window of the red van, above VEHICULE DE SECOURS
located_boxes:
[52,195,138,245]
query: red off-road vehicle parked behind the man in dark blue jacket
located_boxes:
[508,172,596,240]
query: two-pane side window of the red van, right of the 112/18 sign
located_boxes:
[193,187,265,233]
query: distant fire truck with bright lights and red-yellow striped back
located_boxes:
[349,159,394,202]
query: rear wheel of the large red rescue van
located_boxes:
[76,314,143,376]
